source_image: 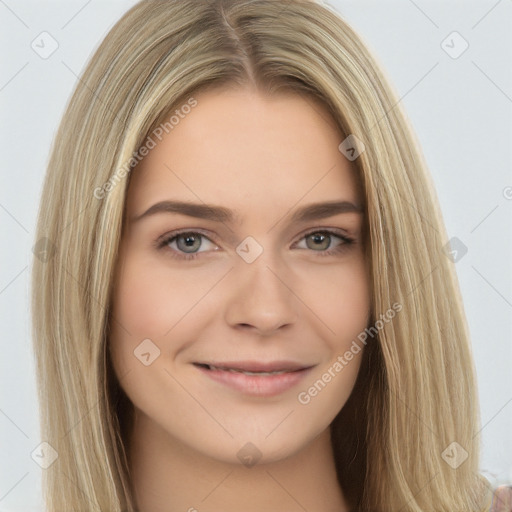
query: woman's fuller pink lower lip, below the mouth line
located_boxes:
[196,366,313,397]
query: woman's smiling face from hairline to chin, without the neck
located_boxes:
[109,90,370,463]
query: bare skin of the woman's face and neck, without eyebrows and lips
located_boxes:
[109,89,370,512]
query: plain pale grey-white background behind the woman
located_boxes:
[0,0,512,512]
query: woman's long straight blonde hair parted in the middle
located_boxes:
[32,0,489,512]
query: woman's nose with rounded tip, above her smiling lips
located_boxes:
[225,252,299,336]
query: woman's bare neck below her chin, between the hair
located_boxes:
[129,410,349,512]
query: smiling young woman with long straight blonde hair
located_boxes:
[33,0,506,512]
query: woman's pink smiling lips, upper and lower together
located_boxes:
[194,361,313,397]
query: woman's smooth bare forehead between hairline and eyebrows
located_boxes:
[127,89,361,213]
